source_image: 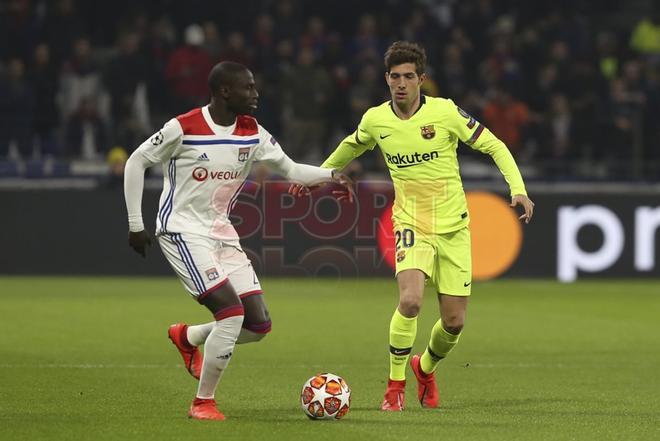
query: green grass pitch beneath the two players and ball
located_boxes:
[0,277,660,441]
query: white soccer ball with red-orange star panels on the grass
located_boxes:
[300,373,351,420]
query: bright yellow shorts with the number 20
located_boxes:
[394,225,472,296]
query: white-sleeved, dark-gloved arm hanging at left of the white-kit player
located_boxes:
[124,119,183,257]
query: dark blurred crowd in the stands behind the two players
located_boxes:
[0,0,660,179]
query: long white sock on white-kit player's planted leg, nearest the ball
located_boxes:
[199,315,248,399]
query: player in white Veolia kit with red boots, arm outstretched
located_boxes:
[124,61,351,420]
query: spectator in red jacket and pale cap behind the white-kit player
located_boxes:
[165,24,212,112]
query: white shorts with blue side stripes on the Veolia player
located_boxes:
[158,233,262,301]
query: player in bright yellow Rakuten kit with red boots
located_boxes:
[292,41,534,411]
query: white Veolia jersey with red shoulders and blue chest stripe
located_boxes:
[138,106,329,243]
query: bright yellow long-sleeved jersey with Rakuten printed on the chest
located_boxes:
[322,95,526,234]
